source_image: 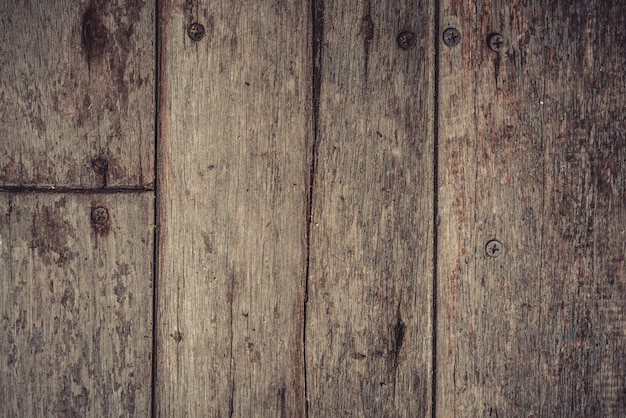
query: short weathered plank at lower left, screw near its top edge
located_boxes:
[0,193,154,417]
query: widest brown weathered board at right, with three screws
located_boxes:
[436,0,626,417]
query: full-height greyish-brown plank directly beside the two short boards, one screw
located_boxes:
[156,0,312,417]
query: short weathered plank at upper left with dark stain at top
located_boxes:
[0,0,155,188]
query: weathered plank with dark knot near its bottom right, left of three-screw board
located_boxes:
[306,1,434,417]
